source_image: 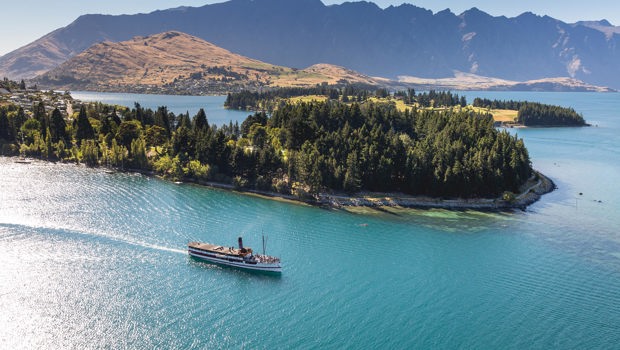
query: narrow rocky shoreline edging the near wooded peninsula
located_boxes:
[3,156,556,211]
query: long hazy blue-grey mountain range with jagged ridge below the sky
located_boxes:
[0,0,620,88]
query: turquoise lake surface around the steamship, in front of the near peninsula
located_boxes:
[0,92,620,349]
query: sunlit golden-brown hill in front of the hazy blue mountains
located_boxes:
[35,31,378,94]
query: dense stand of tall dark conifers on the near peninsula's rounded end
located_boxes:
[268,102,531,197]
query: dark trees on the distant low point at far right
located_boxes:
[474,98,587,126]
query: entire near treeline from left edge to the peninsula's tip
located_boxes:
[0,97,531,197]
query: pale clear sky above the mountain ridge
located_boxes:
[0,0,620,55]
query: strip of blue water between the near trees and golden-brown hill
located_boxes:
[71,91,250,125]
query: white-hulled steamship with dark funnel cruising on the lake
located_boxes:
[187,237,282,273]
